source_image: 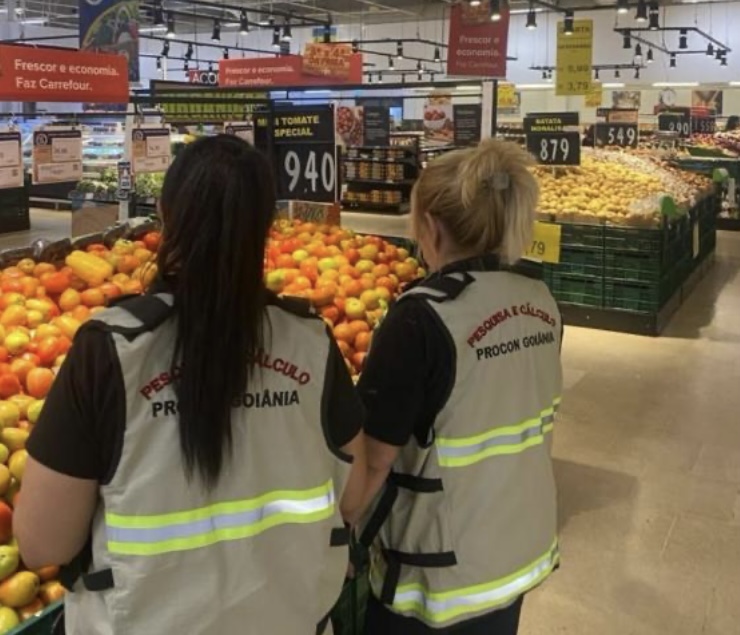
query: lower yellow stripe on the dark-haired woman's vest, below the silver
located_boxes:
[108,505,335,556]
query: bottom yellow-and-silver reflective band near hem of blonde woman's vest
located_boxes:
[393,540,560,624]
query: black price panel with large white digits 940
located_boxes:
[278,143,337,203]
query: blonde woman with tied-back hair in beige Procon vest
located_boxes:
[352,140,562,635]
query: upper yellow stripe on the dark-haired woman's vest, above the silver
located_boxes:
[105,479,334,529]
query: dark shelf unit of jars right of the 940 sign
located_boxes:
[342,138,420,215]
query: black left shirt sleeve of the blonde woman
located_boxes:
[358,298,454,446]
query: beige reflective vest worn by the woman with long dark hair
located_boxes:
[65,294,349,635]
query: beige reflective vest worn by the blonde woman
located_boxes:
[362,271,562,628]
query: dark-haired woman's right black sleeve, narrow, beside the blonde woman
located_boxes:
[324,337,365,449]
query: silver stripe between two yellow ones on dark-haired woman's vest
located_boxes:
[107,490,335,543]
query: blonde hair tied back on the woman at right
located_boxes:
[412,139,539,264]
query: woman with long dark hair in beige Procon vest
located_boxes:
[15,136,364,635]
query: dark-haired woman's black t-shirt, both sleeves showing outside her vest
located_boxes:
[27,306,365,483]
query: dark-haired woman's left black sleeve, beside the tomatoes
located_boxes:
[27,328,126,482]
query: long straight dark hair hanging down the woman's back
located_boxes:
[157,135,275,488]
